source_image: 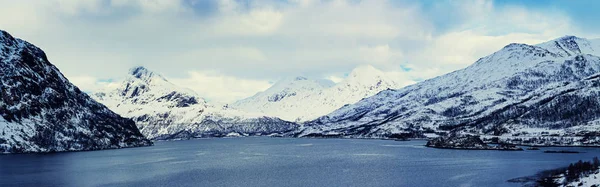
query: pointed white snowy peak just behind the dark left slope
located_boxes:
[92,67,298,140]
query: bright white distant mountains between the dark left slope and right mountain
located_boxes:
[92,66,398,140]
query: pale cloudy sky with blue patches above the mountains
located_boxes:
[0,0,600,102]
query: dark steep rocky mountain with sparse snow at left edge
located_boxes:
[0,30,152,153]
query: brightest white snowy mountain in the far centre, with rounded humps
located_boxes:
[231,65,401,122]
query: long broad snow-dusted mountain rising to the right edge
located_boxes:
[296,36,600,144]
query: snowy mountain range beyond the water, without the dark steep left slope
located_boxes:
[89,36,600,145]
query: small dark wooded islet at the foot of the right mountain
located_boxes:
[425,134,523,151]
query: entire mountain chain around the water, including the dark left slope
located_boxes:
[0,25,600,153]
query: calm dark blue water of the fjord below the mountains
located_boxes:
[0,138,600,187]
